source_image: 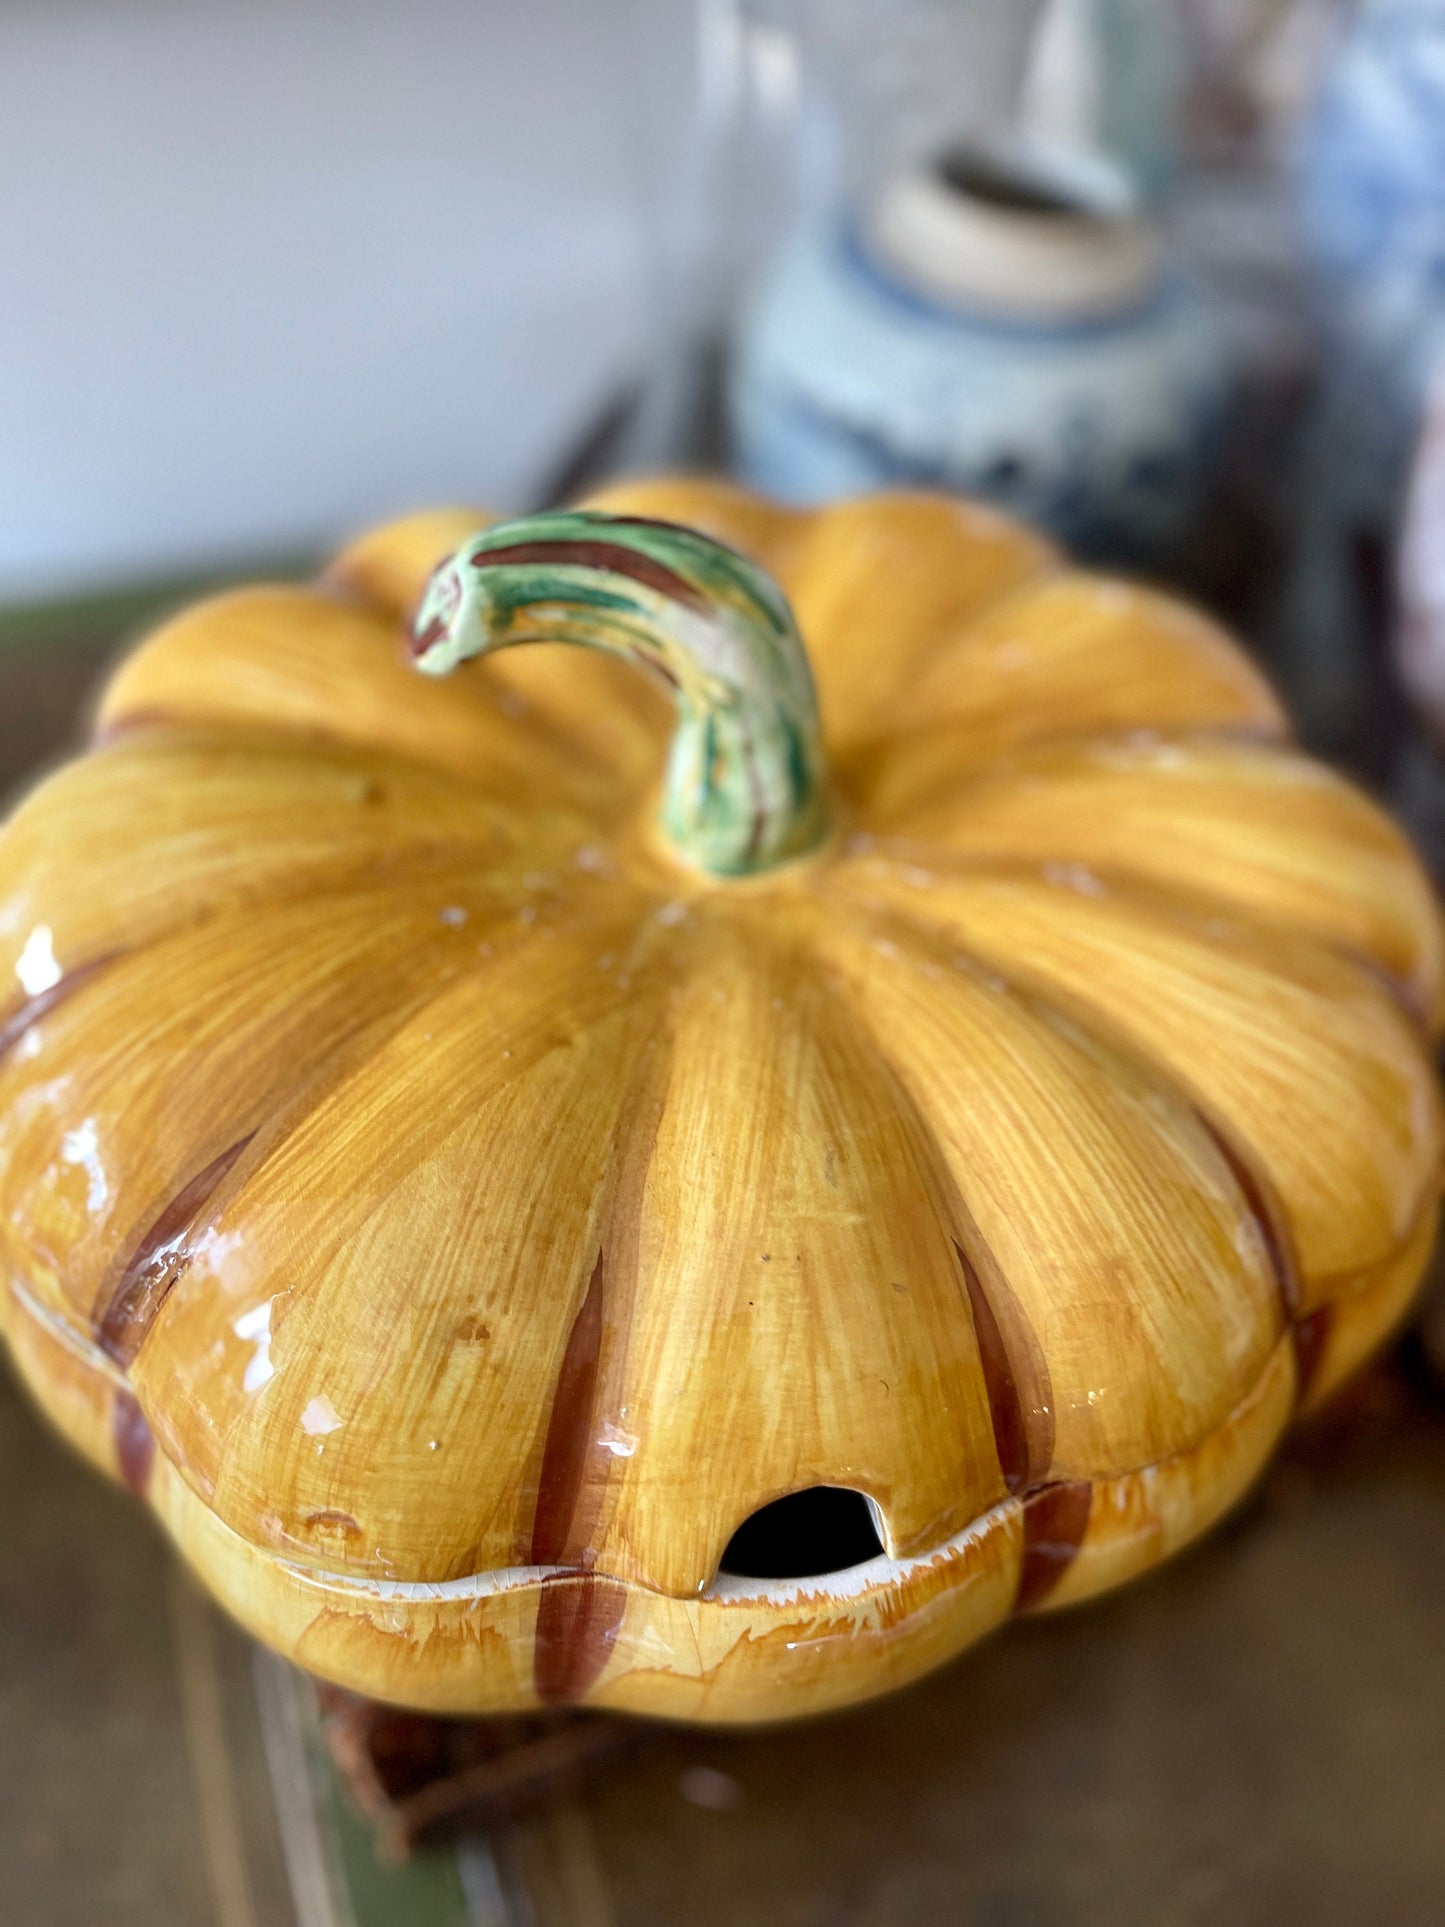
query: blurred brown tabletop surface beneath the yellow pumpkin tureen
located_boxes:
[0,636,1445,1927]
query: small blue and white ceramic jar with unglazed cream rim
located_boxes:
[730,141,1225,561]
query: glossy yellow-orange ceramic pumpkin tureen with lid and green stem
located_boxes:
[0,482,1441,1721]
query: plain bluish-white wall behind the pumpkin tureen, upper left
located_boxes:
[0,0,690,597]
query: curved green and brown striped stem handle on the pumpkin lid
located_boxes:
[412,509,828,877]
